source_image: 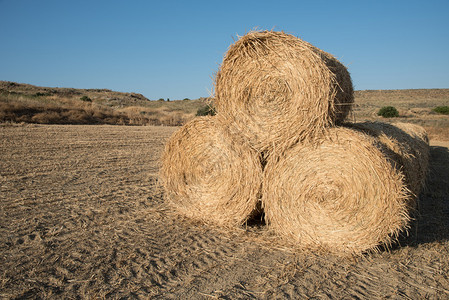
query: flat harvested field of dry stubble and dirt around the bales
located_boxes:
[0,125,449,299]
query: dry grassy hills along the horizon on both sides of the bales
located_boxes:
[0,81,449,127]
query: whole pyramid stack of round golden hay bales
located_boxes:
[161,31,428,255]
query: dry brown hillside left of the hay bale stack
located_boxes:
[0,81,209,126]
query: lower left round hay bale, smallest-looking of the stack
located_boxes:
[160,117,262,227]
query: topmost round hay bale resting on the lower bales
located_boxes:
[214,31,354,151]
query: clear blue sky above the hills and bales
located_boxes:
[0,0,449,100]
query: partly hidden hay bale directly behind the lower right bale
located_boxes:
[351,122,430,196]
